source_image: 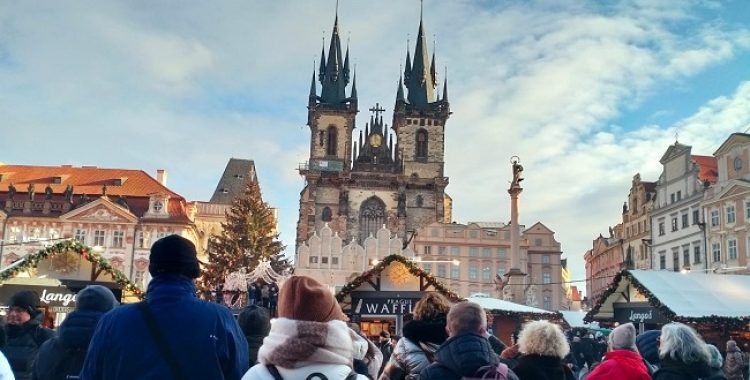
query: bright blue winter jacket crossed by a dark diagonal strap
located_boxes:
[81,275,249,380]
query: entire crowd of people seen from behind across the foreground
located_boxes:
[0,235,748,380]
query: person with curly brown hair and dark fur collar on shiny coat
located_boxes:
[380,293,452,380]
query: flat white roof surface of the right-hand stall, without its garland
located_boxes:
[630,270,750,318]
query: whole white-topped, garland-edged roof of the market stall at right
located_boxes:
[586,270,750,321]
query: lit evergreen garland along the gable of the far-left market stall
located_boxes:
[0,239,144,299]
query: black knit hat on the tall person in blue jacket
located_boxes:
[148,235,200,278]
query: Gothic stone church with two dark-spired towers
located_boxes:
[296,11,451,247]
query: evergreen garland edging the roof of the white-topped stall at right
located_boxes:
[583,269,750,328]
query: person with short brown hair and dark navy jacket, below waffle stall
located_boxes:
[419,301,518,380]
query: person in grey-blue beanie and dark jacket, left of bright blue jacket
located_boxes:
[31,285,120,380]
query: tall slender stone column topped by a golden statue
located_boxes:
[505,156,526,304]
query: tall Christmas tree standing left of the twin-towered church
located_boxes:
[198,175,290,299]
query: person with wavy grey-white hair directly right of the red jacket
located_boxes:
[653,322,711,380]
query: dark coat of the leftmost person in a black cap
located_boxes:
[2,313,55,380]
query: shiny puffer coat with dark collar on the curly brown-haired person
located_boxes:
[380,320,448,380]
